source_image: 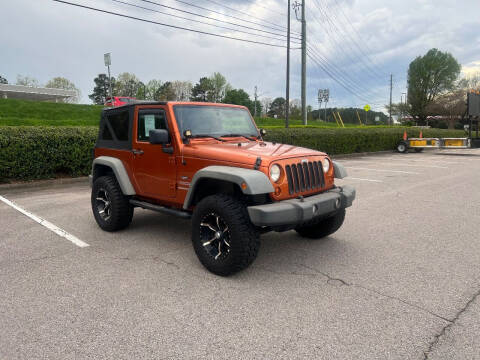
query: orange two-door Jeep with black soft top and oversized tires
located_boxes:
[90,102,355,276]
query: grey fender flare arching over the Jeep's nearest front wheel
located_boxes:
[183,165,275,209]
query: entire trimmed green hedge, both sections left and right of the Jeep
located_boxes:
[0,126,464,182]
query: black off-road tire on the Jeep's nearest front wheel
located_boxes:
[192,194,260,276]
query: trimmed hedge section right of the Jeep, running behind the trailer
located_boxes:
[265,128,465,155]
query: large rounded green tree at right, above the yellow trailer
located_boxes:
[408,49,461,123]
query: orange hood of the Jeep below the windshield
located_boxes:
[184,140,325,164]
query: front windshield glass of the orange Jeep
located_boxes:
[173,105,258,137]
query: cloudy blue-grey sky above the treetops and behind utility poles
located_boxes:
[0,0,480,109]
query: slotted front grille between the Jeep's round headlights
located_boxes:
[285,161,325,195]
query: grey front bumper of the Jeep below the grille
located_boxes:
[248,185,356,226]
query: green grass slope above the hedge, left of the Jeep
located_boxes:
[0,99,103,126]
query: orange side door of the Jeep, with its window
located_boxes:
[132,107,176,199]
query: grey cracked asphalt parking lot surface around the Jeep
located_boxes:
[0,150,480,359]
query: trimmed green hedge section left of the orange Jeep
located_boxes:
[0,126,98,182]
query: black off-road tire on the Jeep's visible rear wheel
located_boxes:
[91,176,133,232]
